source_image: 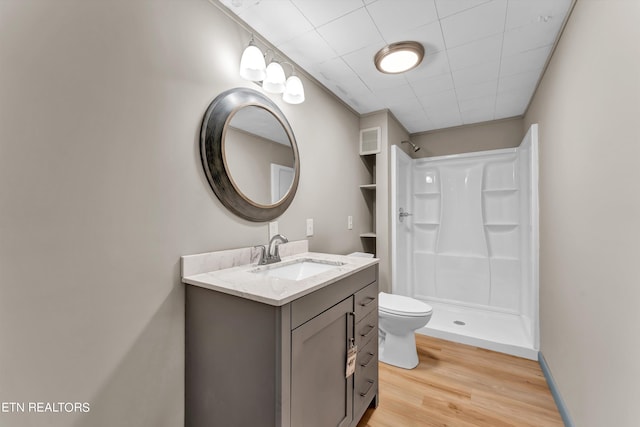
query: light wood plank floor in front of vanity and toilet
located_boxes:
[358,334,564,427]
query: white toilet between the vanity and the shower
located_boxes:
[378,292,433,369]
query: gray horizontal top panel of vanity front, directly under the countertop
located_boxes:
[291,265,377,329]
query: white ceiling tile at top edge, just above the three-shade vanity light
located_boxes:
[240,0,313,46]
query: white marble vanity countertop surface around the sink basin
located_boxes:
[182,252,378,306]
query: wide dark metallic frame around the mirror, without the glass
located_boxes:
[200,88,300,222]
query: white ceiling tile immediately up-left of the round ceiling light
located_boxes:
[318,8,384,55]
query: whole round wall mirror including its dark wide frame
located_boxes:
[200,88,300,221]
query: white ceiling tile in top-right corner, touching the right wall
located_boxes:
[505,0,571,31]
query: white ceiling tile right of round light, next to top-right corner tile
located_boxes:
[440,0,507,49]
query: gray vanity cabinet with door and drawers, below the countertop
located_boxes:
[185,265,378,427]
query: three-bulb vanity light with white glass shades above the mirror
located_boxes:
[240,35,305,104]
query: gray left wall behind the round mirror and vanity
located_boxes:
[0,0,369,427]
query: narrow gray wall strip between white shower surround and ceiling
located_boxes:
[405,118,526,158]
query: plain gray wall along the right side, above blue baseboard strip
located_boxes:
[525,0,640,427]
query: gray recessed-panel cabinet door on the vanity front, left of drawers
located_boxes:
[291,297,353,427]
